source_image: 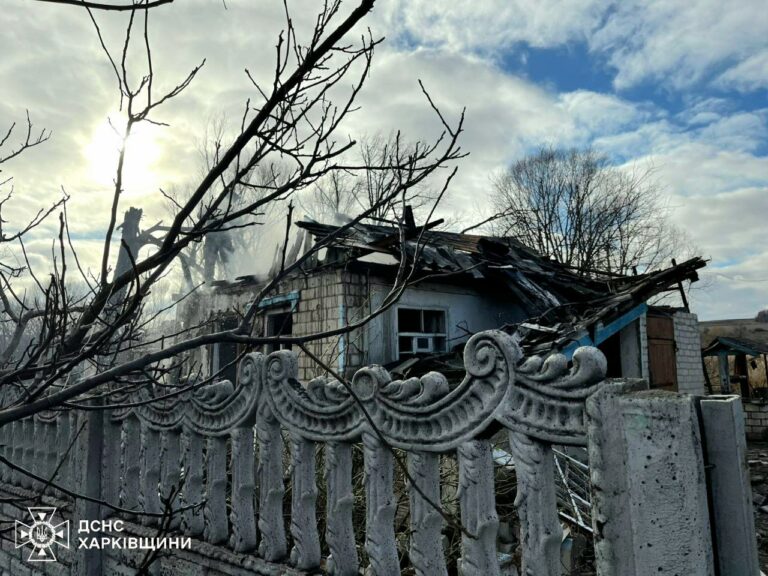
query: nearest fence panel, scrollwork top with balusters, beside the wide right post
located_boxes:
[263,331,606,576]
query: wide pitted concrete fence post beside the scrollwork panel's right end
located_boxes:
[587,382,716,576]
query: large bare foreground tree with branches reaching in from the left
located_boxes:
[0,0,463,426]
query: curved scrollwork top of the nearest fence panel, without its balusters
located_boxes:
[265,331,606,452]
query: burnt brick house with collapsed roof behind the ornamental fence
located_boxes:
[179,214,705,393]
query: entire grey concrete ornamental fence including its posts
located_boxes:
[0,331,759,576]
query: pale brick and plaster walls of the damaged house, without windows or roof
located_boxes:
[185,268,704,394]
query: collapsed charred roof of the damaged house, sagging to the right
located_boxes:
[297,221,706,353]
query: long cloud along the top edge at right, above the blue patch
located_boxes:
[379,0,768,91]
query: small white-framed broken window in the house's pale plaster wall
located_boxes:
[397,308,447,359]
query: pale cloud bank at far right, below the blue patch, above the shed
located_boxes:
[601,120,768,319]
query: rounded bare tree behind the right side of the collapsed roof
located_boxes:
[485,147,683,274]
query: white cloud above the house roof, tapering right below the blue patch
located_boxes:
[346,47,661,214]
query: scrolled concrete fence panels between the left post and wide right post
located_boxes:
[6,331,606,576]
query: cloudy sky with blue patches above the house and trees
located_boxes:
[0,0,768,320]
